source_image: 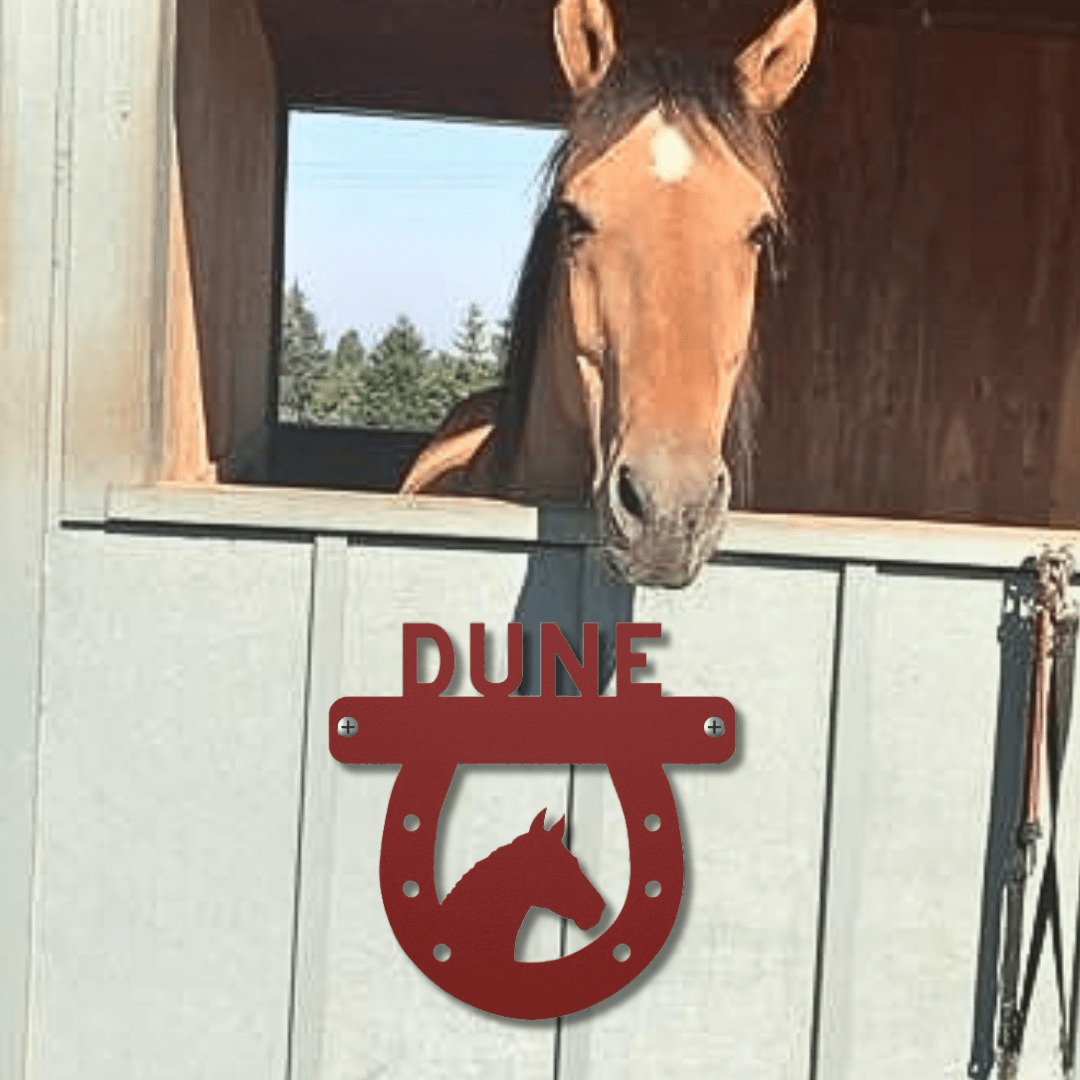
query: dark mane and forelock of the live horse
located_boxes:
[495,41,783,492]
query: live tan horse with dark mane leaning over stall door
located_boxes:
[401,0,818,588]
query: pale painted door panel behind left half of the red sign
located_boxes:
[306,546,568,1080]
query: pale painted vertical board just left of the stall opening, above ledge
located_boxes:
[59,0,174,521]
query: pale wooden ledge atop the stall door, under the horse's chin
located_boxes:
[105,484,1080,569]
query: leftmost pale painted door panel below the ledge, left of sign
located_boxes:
[29,531,310,1080]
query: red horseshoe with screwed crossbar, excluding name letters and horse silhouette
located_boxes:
[329,684,735,1020]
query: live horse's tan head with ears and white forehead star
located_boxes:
[553,0,816,586]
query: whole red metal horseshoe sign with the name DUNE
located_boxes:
[329,623,735,1020]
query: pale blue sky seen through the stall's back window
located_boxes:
[285,112,558,348]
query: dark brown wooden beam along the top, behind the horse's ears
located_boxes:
[259,0,1080,123]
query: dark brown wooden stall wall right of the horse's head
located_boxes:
[751,23,1080,525]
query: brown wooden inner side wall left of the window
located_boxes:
[163,0,278,481]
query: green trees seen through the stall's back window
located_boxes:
[281,295,507,431]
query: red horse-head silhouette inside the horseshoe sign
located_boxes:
[440,809,606,974]
